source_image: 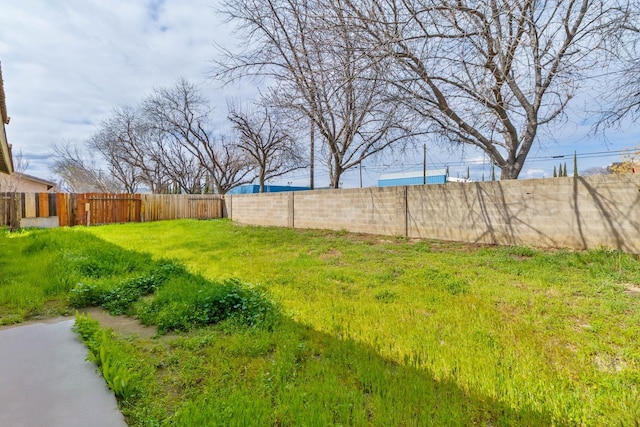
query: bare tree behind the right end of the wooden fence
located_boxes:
[144,79,253,194]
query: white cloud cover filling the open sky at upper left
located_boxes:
[0,0,232,177]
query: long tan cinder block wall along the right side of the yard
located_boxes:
[226,174,640,253]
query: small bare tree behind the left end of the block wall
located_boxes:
[228,103,303,193]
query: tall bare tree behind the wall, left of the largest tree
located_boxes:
[215,0,411,188]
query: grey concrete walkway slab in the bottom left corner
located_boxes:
[0,320,126,427]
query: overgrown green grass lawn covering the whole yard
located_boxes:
[0,220,640,426]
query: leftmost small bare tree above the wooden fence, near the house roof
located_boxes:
[51,142,124,193]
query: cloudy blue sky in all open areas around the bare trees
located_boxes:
[0,0,640,187]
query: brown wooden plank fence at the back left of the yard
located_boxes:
[0,193,224,228]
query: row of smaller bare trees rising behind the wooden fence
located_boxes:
[52,79,305,194]
